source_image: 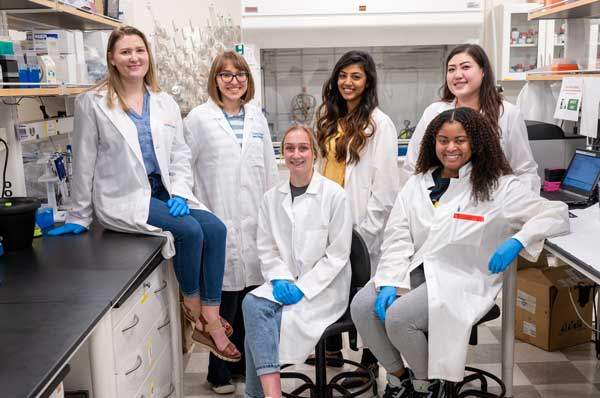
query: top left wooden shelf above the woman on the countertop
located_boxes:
[0,0,121,30]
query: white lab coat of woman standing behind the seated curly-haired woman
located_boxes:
[400,100,541,194]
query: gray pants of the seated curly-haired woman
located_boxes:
[350,266,429,380]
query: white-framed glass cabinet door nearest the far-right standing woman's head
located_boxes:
[499,7,547,80]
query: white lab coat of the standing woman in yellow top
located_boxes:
[319,108,399,275]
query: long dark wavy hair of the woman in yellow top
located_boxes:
[317,51,379,163]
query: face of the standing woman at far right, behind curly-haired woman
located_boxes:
[446,52,483,103]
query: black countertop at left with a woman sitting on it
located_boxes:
[0,225,164,398]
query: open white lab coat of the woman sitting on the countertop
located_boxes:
[66,90,204,258]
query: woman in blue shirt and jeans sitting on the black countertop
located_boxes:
[49,26,241,361]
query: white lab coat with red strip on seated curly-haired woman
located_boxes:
[374,163,569,381]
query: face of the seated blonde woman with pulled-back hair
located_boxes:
[283,129,316,181]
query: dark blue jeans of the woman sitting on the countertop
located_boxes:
[148,184,227,306]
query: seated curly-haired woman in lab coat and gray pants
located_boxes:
[351,108,569,398]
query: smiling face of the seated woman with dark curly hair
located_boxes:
[435,121,472,178]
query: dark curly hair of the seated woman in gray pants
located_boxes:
[415,108,512,202]
